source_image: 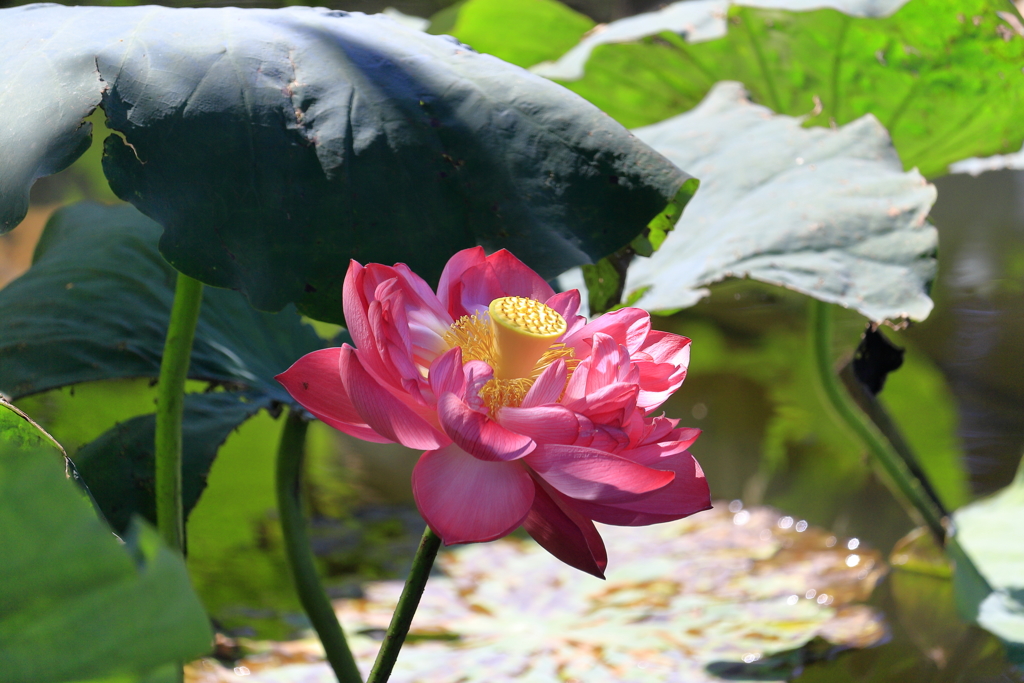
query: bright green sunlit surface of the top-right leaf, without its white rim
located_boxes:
[570,0,1024,176]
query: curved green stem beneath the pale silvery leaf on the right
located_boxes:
[811,300,946,546]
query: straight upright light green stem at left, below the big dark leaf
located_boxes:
[156,272,203,552]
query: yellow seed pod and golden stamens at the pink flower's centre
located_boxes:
[444,297,577,411]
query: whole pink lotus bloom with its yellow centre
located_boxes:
[278,247,711,578]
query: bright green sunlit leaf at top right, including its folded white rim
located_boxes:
[520,0,1024,176]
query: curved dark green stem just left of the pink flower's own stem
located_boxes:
[276,411,362,683]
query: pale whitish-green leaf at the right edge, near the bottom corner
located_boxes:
[953,460,1024,663]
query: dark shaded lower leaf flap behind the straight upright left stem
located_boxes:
[75,392,269,532]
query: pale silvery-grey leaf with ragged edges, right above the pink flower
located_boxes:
[562,82,937,321]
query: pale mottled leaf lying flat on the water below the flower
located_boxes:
[190,503,886,683]
